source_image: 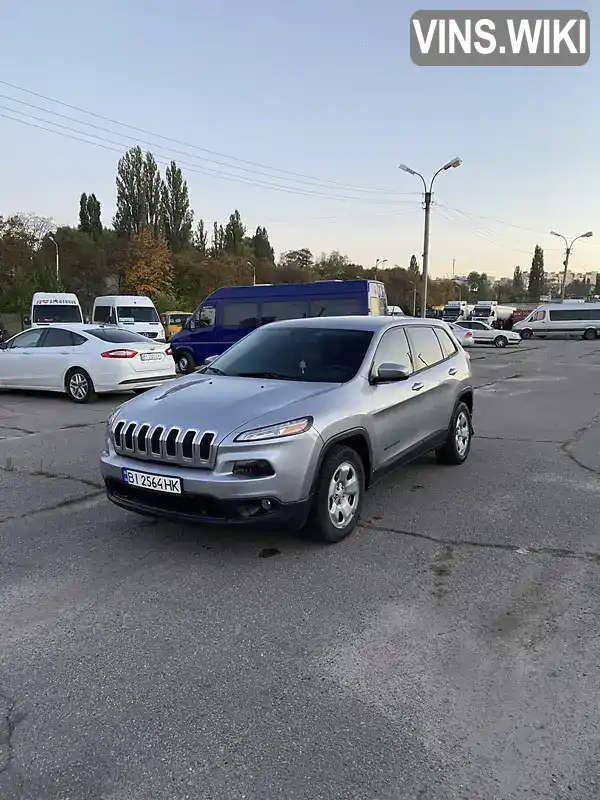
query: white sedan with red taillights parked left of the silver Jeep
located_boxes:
[0,323,176,403]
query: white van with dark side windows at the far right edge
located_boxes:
[513,300,600,339]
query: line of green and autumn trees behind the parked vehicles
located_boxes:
[0,147,598,314]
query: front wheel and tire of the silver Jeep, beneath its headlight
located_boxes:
[307,445,365,544]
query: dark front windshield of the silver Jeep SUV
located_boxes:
[206,326,373,383]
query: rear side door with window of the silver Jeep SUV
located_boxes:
[406,325,456,442]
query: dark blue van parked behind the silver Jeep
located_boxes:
[169,280,387,374]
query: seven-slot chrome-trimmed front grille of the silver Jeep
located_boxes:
[111,420,217,469]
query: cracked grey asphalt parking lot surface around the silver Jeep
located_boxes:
[0,341,600,800]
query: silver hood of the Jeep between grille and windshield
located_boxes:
[113,374,340,440]
